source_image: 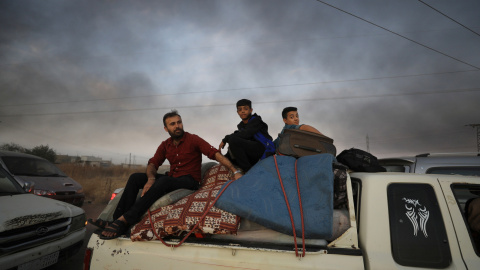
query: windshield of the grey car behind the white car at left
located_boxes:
[2,157,66,176]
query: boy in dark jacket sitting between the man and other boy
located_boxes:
[219,99,275,172]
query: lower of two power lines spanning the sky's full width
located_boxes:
[0,88,480,117]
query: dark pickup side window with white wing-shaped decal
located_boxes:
[387,183,452,268]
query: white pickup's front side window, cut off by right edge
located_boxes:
[452,184,480,256]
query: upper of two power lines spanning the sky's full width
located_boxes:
[1,70,478,108]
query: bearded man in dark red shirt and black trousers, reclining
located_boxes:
[95,110,242,239]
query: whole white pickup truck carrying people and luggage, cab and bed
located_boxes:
[84,163,480,270]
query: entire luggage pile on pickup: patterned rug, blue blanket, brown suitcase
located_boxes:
[131,130,349,241]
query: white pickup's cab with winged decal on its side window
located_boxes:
[351,173,480,269]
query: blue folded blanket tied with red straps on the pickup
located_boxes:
[215,154,334,239]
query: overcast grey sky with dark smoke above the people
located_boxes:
[0,0,480,164]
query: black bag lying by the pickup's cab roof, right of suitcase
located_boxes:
[337,148,387,172]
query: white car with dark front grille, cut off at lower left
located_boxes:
[0,166,86,270]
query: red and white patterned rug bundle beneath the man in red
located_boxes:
[130,165,240,241]
